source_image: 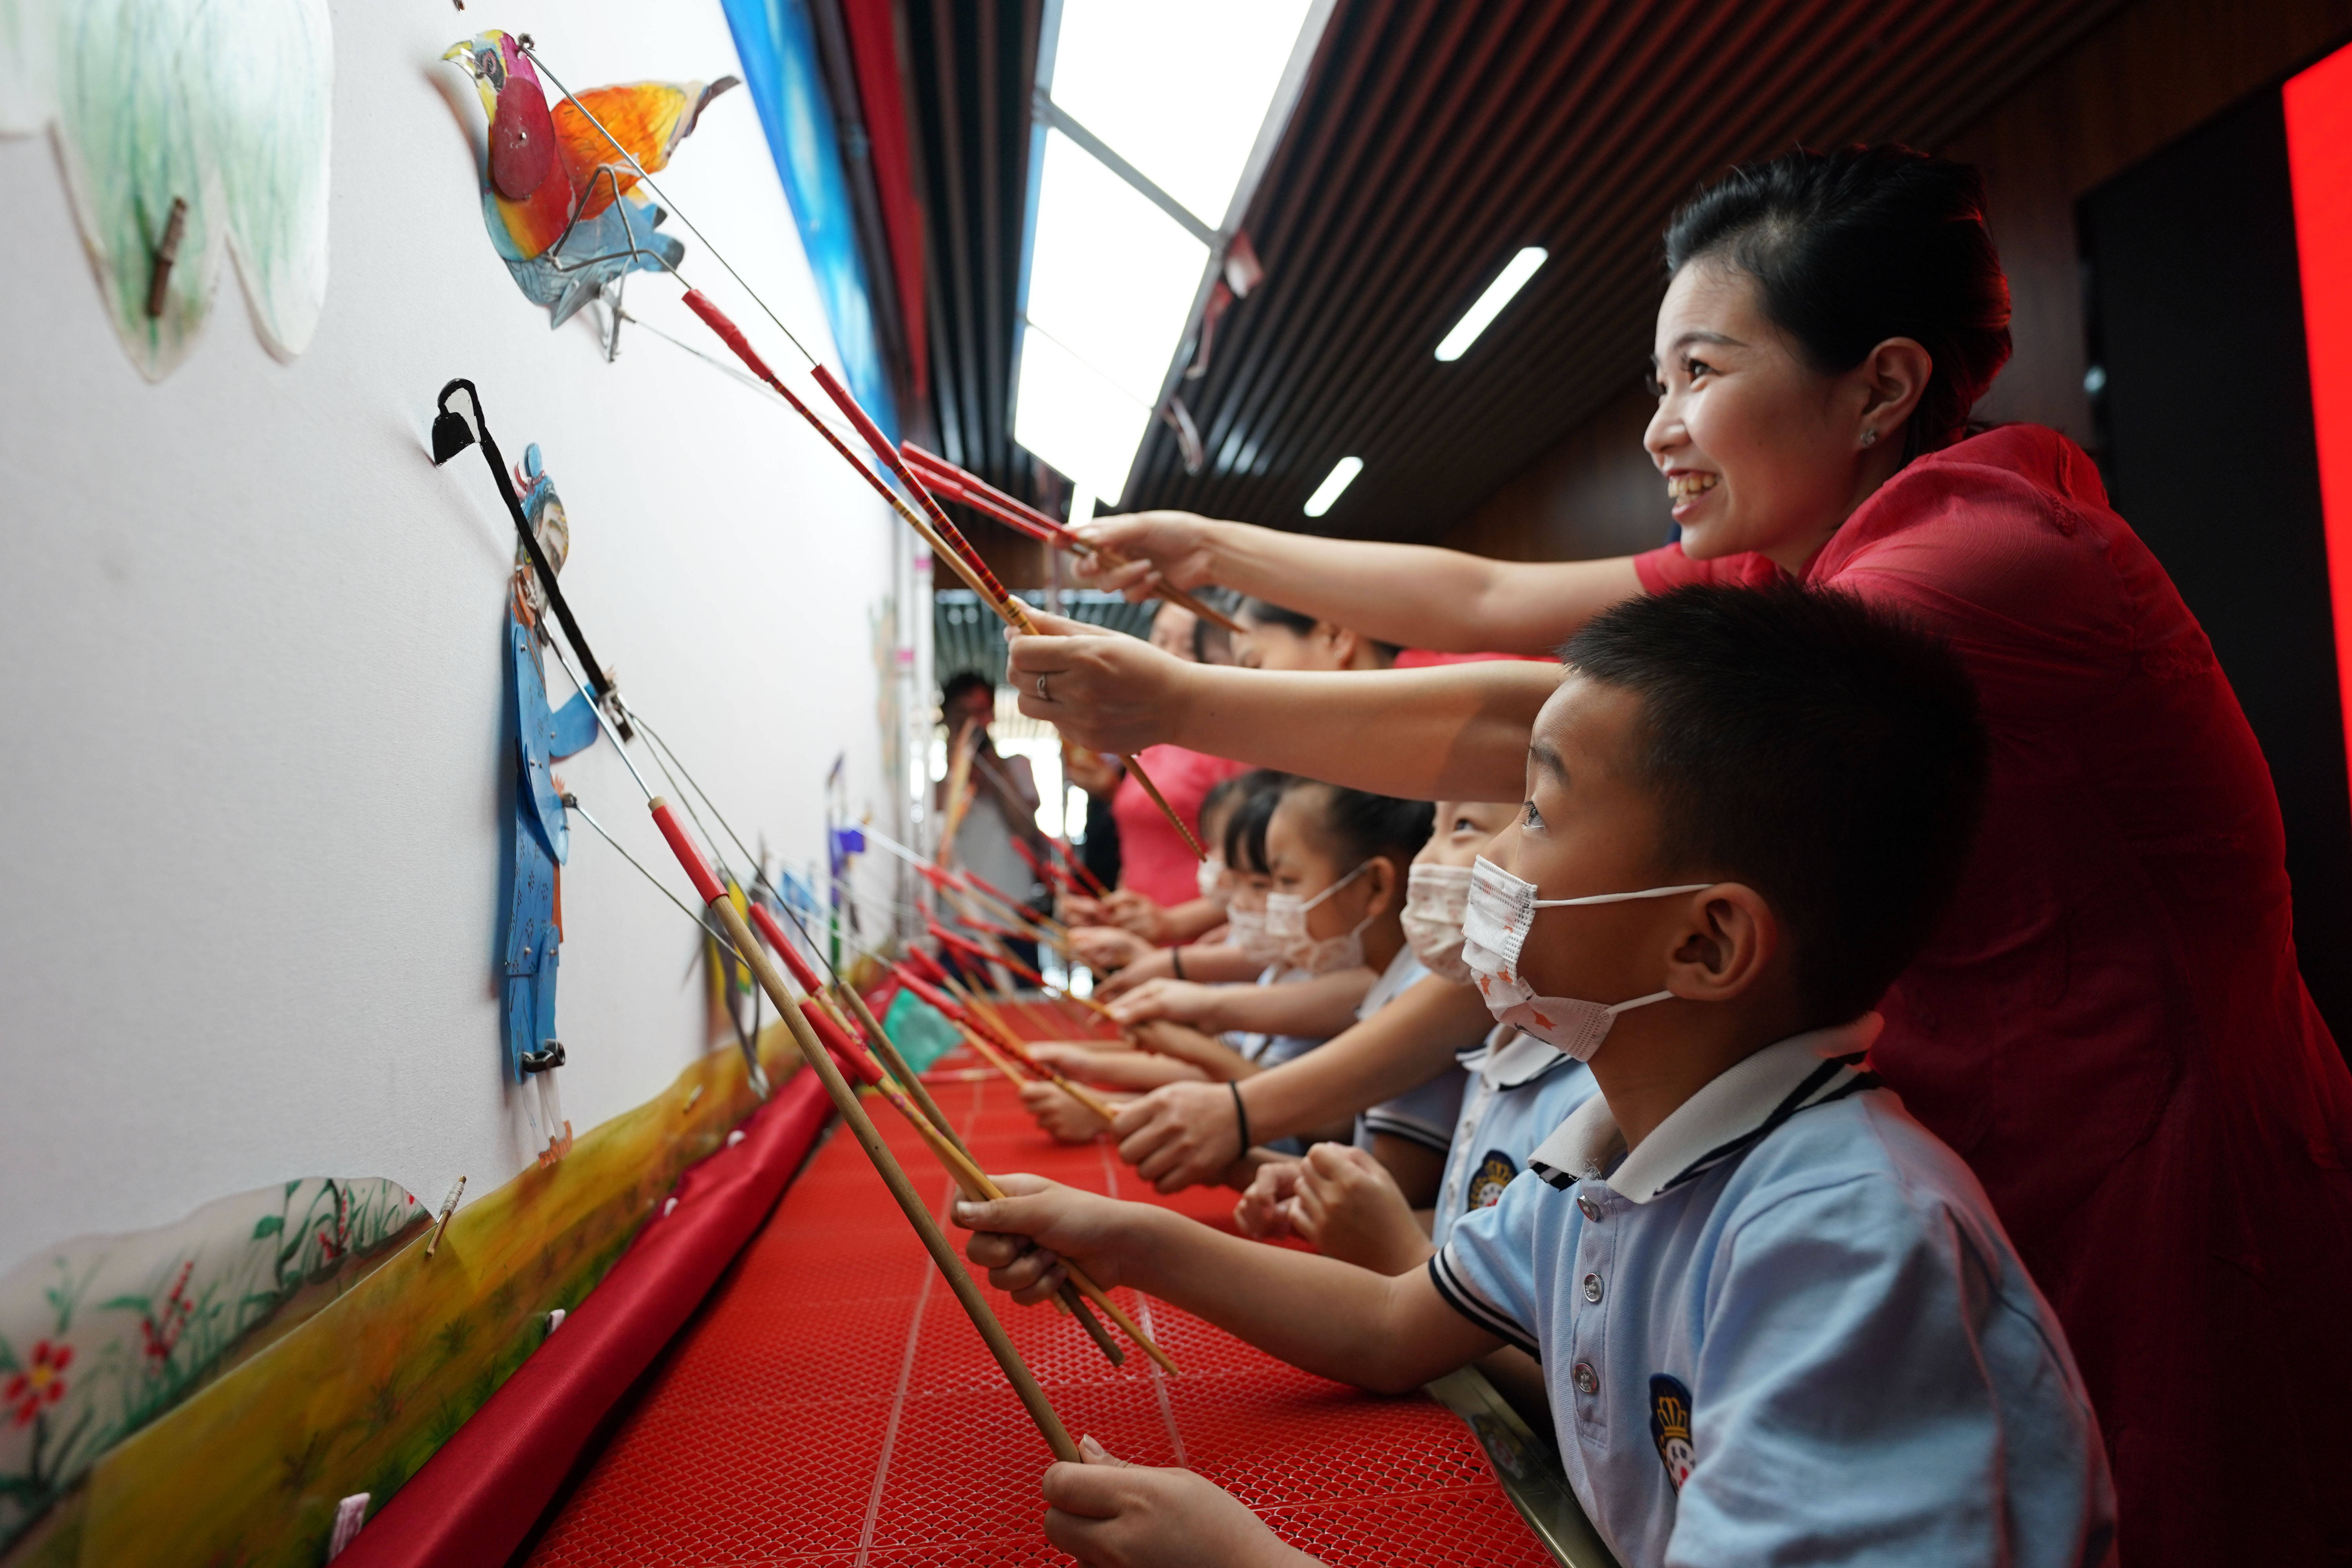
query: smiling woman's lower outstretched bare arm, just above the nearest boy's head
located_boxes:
[1009,613,1559,802]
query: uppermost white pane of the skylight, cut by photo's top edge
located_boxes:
[1051,0,1312,228]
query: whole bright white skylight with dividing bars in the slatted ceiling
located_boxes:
[1014,0,1334,503]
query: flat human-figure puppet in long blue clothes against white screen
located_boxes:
[503,442,597,1164]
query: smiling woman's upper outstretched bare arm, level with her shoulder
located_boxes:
[1077,512,1642,653]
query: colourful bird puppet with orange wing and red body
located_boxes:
[442,31,736,327]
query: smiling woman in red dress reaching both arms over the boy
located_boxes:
[1014,148,2352,1566]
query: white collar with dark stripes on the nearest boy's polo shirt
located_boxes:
[1526,1013,1882,1203]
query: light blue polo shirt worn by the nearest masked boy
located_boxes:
[1430,1016,2126,1568]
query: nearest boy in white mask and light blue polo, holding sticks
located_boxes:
[955,585,2114,1568]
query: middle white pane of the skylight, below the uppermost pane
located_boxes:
[1023,129,1209,404]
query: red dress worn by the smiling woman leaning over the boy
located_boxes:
[1635,425,2352,1563]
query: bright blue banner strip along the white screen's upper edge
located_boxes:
[722,0,898,439]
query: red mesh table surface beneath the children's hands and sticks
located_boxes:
[529,1062,1552,1568]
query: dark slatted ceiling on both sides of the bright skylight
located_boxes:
[908,0,2119,552]
